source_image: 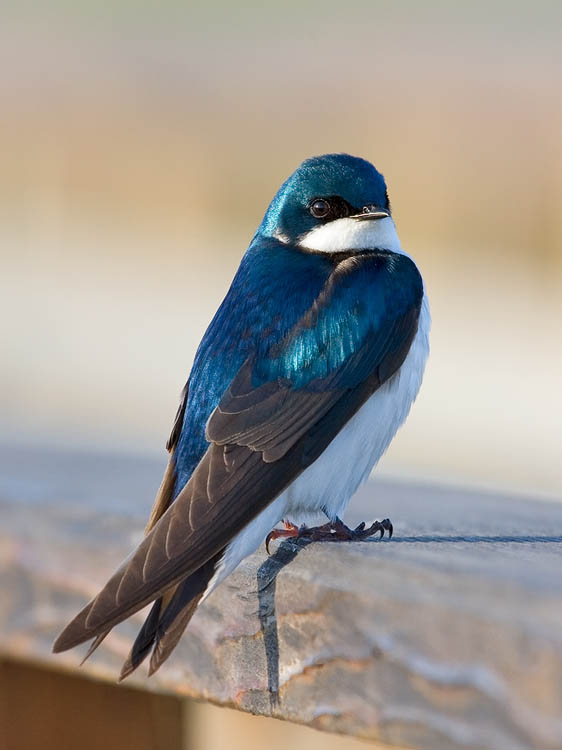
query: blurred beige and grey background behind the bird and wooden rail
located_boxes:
[0,0,562,748]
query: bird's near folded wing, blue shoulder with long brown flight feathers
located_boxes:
[55,252,423,650]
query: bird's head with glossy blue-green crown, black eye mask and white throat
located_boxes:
[258,154,398,252]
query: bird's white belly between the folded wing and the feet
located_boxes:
[205,294,431,596]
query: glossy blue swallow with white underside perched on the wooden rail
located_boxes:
[53,153,431,680]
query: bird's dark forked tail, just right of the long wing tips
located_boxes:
[119,550,222,682]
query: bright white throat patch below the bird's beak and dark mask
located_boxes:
[299,216,405,255]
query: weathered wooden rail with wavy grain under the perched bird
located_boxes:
[0,448,562,750]
